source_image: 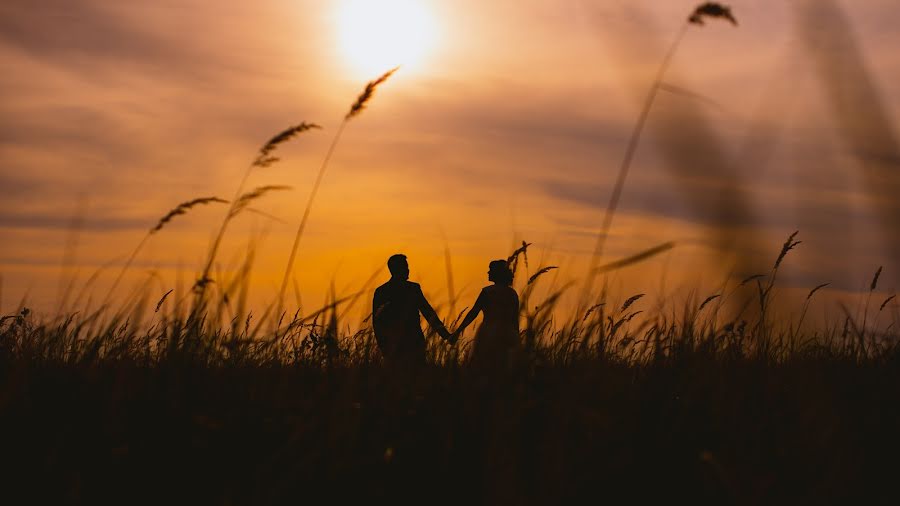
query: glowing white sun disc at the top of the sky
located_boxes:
[337,0,437,78]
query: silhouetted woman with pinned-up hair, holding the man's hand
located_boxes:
[454,260,519,366]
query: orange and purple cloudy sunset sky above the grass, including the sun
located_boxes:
[0,0,900,314]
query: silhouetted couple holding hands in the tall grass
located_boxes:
[372,255,519,365]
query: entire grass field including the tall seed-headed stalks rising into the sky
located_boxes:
[0,3,900,500]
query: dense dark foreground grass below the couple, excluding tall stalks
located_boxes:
[0,306,900,505]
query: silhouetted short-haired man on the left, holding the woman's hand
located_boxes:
[372,255,453,364]
